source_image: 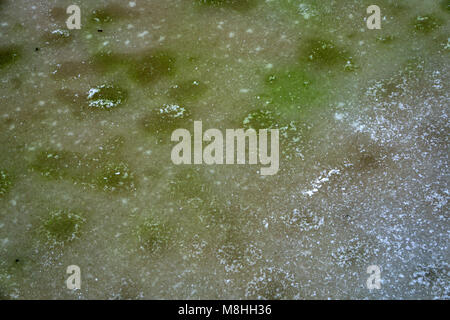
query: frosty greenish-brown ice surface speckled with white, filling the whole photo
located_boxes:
[0,0,450,299]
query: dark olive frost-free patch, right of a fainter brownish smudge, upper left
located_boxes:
[129,50,176,84]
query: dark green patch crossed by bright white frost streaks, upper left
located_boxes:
[87,84,128,110]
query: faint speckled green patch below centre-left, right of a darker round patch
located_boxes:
[135,218,172,253]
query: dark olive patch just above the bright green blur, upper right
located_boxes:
[301,39,356,71]
